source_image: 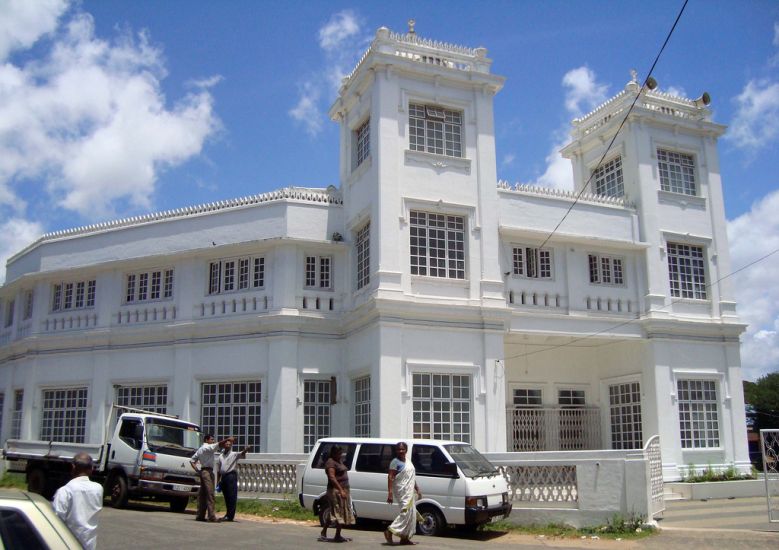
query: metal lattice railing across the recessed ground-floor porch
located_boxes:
[506,407,602,451]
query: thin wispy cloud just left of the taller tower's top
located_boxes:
[288,10,370,136]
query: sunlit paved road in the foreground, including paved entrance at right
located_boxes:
[98,499,779,550]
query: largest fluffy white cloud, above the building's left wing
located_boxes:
[0,7,219,220]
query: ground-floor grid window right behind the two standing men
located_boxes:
[200,381,262,453]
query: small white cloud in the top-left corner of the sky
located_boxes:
[0,0,68,61]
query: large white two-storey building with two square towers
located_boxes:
[0,28,749,480]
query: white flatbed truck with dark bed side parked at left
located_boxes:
[3,407,200,512]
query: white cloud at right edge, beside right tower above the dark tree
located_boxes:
[728,191,779,380]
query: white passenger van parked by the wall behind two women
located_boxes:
[299,437,511,535]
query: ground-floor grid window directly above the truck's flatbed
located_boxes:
[40,388,87,443]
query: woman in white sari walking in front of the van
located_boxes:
[384,441,422,544]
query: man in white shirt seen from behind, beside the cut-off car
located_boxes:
[52,452,103,550]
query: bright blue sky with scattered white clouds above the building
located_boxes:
[0,0,779,380]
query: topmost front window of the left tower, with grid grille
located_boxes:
[408,104,463,157]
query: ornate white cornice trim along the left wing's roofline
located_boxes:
[8,186,343,262]
